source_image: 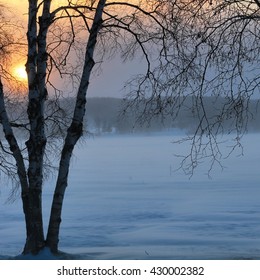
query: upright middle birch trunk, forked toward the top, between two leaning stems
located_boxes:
[23,0,51,254]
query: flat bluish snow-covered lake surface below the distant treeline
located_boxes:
[0,134,260,259]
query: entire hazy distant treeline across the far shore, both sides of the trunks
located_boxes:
[0,97,260,140]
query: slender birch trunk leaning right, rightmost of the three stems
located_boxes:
[46,0,106,253]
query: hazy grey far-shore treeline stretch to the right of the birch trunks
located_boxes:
[85,97,260,134]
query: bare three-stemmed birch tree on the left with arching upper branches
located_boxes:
[0,0,179,254]
